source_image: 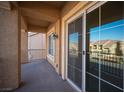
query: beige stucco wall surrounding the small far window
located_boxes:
[47,20,61,74]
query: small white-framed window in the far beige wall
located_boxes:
[48,34,55,56]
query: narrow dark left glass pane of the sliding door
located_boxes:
[67,17,82,90]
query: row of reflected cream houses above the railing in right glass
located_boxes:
[90,40,124,55]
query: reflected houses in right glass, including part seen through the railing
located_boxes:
[90,40,124,63]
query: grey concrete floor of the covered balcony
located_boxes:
[15,60,75,92]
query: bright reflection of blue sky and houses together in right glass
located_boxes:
[90,19,124,63]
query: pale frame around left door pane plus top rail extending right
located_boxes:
[65,1,107,92]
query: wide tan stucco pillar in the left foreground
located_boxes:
[0,9,20,91]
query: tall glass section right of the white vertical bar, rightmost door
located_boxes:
[99,2,124,91]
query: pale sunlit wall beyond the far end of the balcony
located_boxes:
[28,33,46,61]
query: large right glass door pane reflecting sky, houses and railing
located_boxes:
[86,1,124,92]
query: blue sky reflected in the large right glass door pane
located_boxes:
[90,19,124,41]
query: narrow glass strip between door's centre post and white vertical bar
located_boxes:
[86,8,99,91]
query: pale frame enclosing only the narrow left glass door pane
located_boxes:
[66,12,85,92]
